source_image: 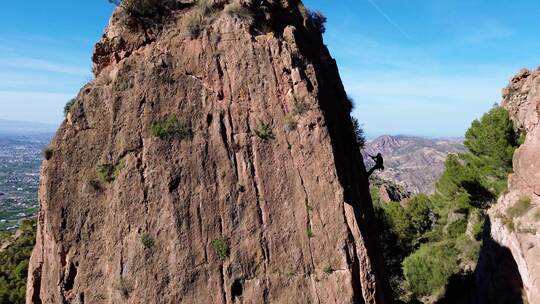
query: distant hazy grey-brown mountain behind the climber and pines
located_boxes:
[362,135,465,193]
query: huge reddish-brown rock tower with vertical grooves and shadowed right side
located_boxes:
[27,0,386,303]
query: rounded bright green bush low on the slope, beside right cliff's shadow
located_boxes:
[403,242,458,297]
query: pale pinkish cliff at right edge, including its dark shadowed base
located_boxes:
[477,70,540,304]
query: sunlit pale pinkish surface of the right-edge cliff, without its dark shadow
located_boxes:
[477,70,540,304]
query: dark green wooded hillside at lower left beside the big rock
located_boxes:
[0,220,36,304]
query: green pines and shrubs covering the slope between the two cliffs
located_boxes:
[372,106,520,303]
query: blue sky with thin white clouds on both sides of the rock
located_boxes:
[0,0,540,136]
